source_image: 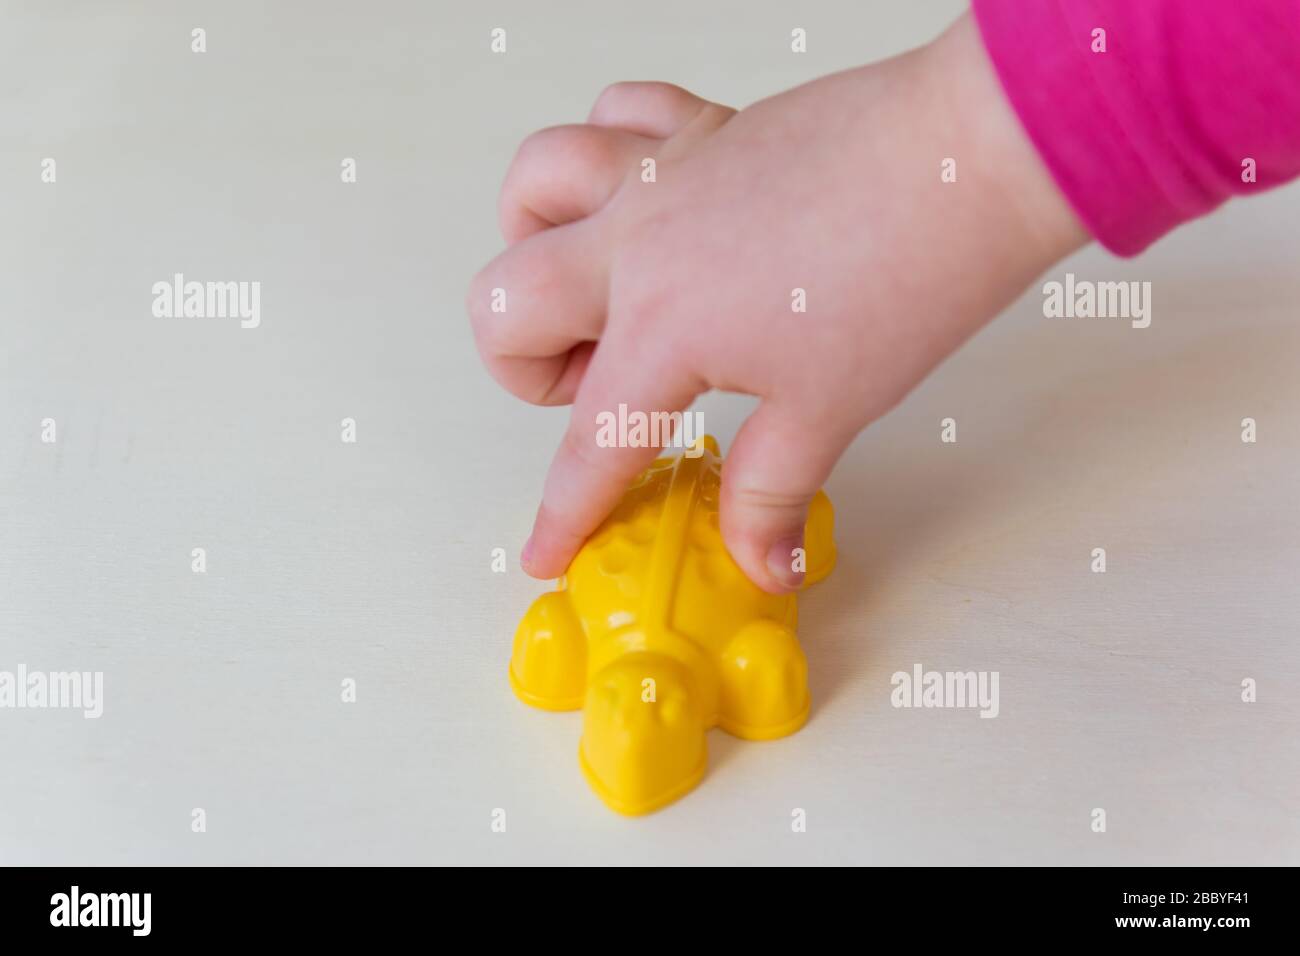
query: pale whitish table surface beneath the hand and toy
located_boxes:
[0,0,1300,864]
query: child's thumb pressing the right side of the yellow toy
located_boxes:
[720,402,854,593]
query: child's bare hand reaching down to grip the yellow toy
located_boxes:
[469,17,1087,591]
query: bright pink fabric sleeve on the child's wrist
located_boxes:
[974,0,1300,255]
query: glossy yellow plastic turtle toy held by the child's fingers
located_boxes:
[510,436,835,814]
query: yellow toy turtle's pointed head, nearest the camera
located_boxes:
[579,652,707,816]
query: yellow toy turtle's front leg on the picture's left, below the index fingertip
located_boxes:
[510,591,586,710]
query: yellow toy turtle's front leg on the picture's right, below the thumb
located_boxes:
[718,619,810,740]
